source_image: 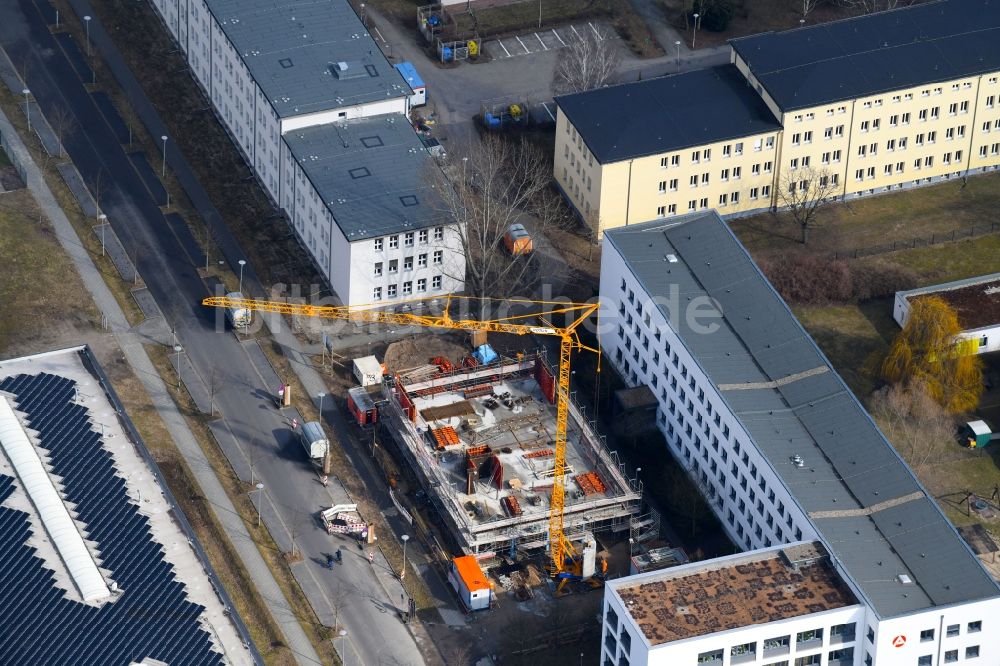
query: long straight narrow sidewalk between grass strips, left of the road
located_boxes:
[0,105,320,664]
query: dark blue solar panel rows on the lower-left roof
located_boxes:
[0,373,224,666]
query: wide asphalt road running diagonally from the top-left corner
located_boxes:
[0,0,423,664]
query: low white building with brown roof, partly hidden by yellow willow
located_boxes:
[892,273,1000,354]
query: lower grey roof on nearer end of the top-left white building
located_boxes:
[283,113,447,241]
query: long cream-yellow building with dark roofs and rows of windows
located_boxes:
[554,0,1000,234]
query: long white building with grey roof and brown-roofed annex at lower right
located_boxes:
[599,211,1000,666]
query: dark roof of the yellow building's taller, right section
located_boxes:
[730,0,1000,111]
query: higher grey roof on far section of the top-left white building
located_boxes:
[207,0,411,118]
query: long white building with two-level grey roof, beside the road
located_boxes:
[147,0,465,305]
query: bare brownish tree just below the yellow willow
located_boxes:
[871,383,954,473]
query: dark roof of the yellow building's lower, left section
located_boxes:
[556,65,780,164]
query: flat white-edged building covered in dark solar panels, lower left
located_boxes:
[0,347,254,664]
